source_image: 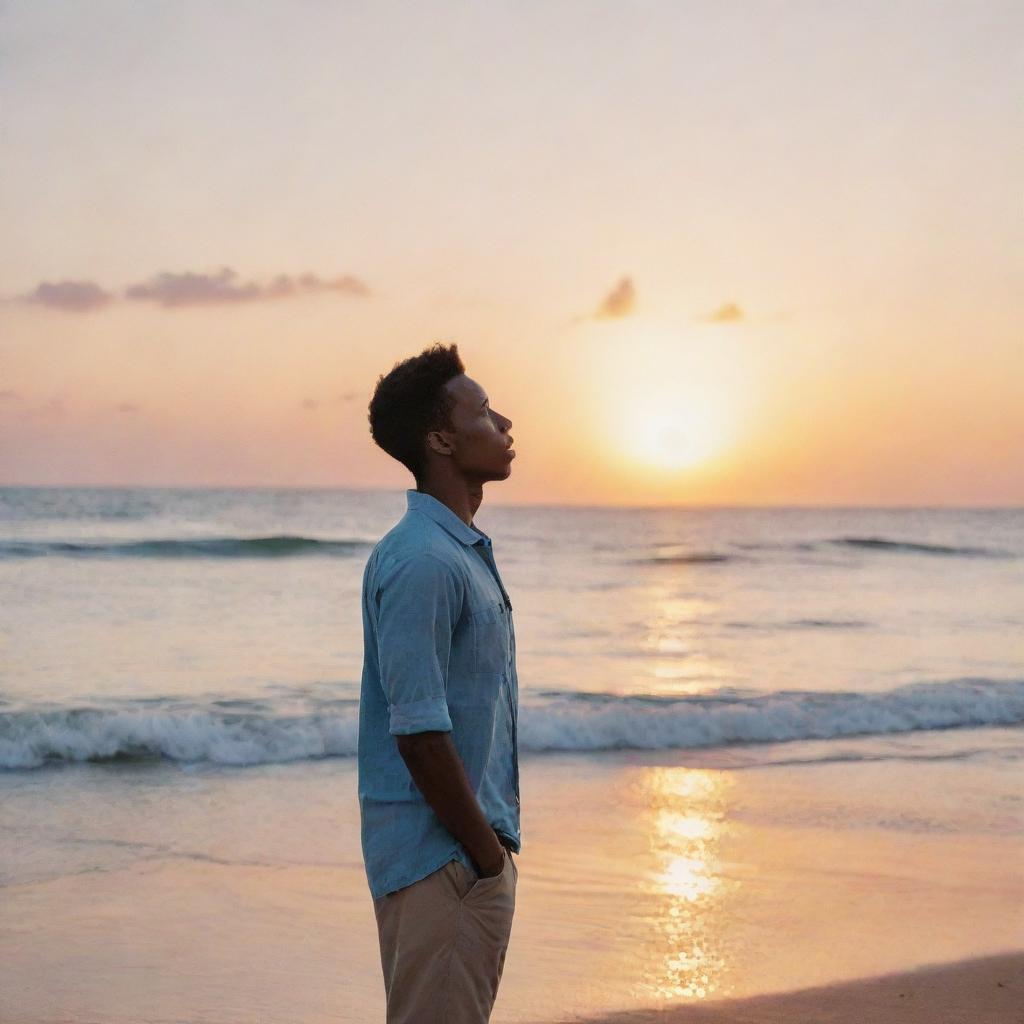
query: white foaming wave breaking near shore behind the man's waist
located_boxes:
[0,678,1024,769]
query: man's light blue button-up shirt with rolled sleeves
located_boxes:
[356,488,520,899]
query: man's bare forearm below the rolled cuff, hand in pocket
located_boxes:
[394,731,505,878]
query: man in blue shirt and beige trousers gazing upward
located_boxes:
[357,344,520,1024]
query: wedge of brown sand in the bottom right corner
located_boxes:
[546,950,1024,1024]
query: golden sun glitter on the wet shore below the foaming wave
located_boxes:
[635,767,735,1001]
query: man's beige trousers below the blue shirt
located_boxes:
[374,850,519,1024]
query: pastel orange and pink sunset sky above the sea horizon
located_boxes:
[0,0,1024,506]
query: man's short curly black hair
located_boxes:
[367,342,466,487]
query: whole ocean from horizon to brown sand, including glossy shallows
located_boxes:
[0,485,1024,1024]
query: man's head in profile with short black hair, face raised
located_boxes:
[368,343,513,489]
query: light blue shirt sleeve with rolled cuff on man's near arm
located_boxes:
[377,553,462,736]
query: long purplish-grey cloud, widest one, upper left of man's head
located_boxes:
[124,266,370,308]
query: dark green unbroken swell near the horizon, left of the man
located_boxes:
[0,534,371,558]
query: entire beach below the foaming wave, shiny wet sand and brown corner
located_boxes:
[0,749,1024,1024]
